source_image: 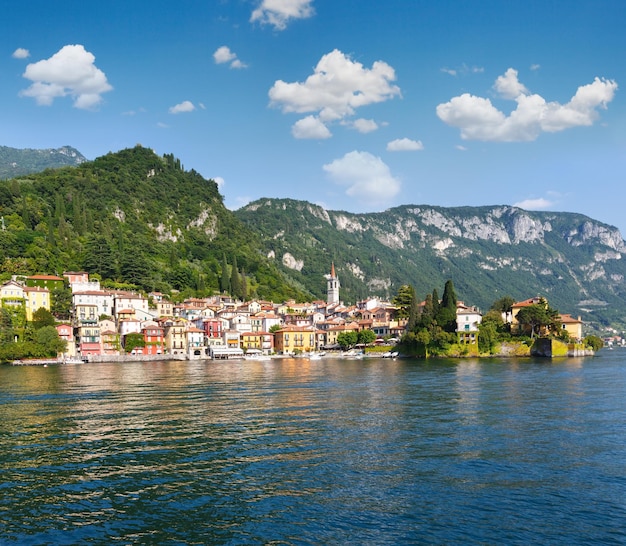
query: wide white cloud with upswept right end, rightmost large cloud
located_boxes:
[437,69,617,142]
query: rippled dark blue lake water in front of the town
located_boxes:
[0,349,626,544]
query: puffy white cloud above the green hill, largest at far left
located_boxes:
[20,45,113,109]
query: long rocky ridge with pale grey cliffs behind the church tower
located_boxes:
[236,199,626,324]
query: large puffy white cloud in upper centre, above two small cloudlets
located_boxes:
[269,49,400,132]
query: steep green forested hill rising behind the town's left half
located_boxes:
[0,146,310,301]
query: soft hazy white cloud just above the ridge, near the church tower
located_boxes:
[323,151,400,209]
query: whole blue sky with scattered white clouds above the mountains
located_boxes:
[0,0,626,235]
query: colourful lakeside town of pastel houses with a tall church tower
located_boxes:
[0,264,597,364]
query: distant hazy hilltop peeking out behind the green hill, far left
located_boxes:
[0,146,87,179]
